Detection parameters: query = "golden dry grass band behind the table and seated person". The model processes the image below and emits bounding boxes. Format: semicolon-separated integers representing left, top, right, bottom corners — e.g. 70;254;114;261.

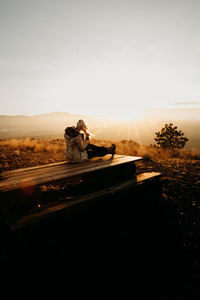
0;138;200;170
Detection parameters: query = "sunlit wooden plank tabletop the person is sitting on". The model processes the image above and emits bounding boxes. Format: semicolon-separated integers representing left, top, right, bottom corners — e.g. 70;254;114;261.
0;155;142;192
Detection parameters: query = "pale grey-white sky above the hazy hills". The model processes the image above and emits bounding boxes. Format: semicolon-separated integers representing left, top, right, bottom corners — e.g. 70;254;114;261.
0;0;200;119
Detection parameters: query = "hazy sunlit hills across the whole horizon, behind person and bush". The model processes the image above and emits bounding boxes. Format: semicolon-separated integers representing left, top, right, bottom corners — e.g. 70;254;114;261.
0;111;200;150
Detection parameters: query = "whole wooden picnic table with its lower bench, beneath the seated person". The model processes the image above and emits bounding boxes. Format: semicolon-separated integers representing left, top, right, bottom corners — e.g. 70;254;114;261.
0;155;161;229
